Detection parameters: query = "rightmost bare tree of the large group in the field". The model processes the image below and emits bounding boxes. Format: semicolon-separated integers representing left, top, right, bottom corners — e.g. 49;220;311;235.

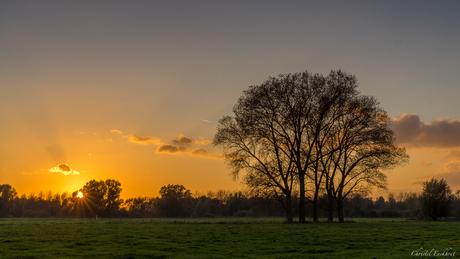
322;95;408;222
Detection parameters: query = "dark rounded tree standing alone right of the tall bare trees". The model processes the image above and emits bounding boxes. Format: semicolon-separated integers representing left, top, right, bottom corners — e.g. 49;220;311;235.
420;178;453;221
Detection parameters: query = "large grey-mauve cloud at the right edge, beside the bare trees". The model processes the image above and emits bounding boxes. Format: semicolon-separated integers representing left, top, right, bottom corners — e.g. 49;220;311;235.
390;114;460;148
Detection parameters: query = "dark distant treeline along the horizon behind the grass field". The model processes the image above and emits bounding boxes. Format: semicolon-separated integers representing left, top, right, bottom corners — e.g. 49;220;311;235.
0;179;460;220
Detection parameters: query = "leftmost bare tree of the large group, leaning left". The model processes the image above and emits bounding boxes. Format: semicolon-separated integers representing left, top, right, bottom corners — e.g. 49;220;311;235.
213;116;294;222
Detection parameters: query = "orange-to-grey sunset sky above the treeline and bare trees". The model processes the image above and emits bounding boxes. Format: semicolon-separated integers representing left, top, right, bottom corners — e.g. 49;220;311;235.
0;0;460;198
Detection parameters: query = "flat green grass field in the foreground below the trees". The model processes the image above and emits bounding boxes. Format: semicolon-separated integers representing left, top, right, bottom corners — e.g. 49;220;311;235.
0;219;460;259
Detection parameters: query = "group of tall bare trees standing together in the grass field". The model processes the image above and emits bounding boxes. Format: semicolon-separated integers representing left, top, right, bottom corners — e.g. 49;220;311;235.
213;70;408;222
